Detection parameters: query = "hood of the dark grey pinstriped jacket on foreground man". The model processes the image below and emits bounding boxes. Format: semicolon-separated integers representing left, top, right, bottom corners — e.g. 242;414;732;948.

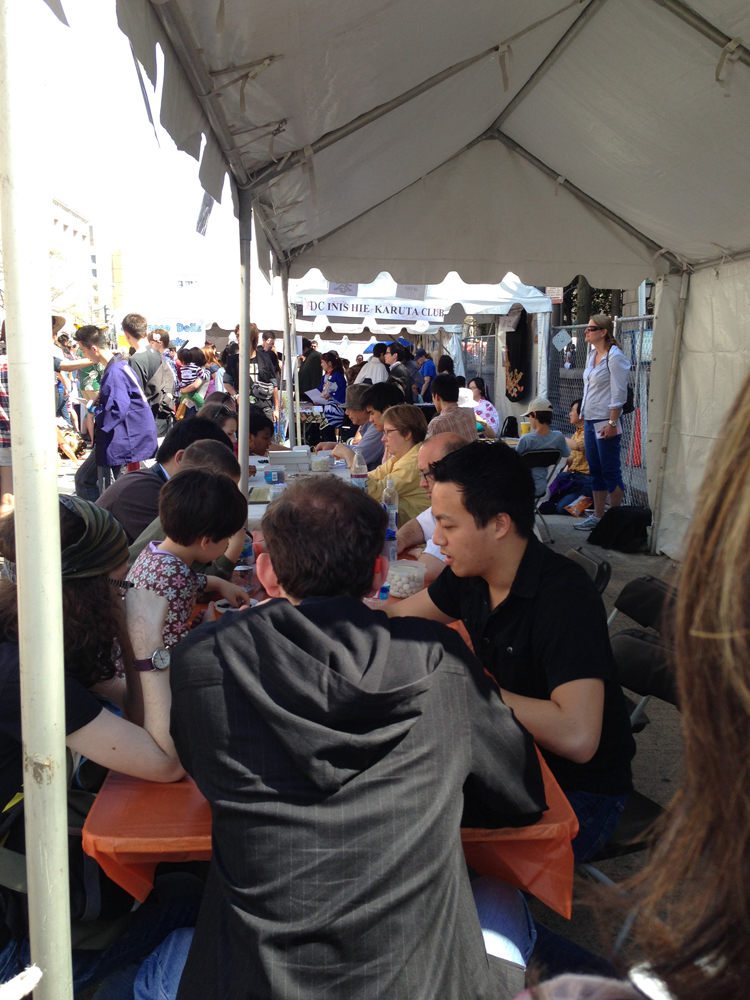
216;597;444;793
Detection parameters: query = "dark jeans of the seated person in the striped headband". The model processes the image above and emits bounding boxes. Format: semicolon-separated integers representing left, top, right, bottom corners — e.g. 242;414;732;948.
0;872;203;1000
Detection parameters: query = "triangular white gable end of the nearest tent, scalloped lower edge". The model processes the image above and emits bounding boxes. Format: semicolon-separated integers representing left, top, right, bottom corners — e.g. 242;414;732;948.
292;142;664;288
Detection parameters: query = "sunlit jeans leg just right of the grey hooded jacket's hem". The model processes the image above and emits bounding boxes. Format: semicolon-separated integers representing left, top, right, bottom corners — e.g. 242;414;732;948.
471;875;536;968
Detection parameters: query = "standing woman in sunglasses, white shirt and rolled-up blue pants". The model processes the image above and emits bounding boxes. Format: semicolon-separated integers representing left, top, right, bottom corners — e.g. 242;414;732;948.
576;315;630;531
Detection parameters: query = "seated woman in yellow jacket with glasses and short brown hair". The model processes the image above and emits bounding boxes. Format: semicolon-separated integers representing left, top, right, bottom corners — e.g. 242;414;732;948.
367;403;430;528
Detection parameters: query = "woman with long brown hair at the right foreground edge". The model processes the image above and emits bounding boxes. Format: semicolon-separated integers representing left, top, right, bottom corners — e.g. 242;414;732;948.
533;370;750;1000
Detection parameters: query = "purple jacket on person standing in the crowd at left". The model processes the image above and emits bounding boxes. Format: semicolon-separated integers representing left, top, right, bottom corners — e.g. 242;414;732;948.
95;355;157;465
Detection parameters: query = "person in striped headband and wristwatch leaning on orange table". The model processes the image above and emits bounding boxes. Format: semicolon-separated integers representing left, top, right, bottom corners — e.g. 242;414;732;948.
0;496;202;995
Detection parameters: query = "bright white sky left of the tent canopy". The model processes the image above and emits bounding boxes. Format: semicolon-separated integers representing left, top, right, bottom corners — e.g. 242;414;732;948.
27;0;280;326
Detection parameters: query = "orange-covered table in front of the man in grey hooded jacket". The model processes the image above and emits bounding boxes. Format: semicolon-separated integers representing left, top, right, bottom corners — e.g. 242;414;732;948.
83;752;578;917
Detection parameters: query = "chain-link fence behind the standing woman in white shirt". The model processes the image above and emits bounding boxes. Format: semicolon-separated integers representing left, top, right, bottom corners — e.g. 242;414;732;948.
547;316;654;506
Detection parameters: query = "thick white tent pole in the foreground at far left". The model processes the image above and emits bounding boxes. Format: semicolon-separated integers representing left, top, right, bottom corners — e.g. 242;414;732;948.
0;0;73;1000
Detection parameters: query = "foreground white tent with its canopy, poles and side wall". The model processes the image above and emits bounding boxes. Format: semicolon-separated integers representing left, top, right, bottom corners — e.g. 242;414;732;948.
0;0;750;1000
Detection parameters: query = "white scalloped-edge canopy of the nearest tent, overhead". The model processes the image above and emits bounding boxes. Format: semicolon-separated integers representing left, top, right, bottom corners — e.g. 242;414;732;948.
110;0;750;554
